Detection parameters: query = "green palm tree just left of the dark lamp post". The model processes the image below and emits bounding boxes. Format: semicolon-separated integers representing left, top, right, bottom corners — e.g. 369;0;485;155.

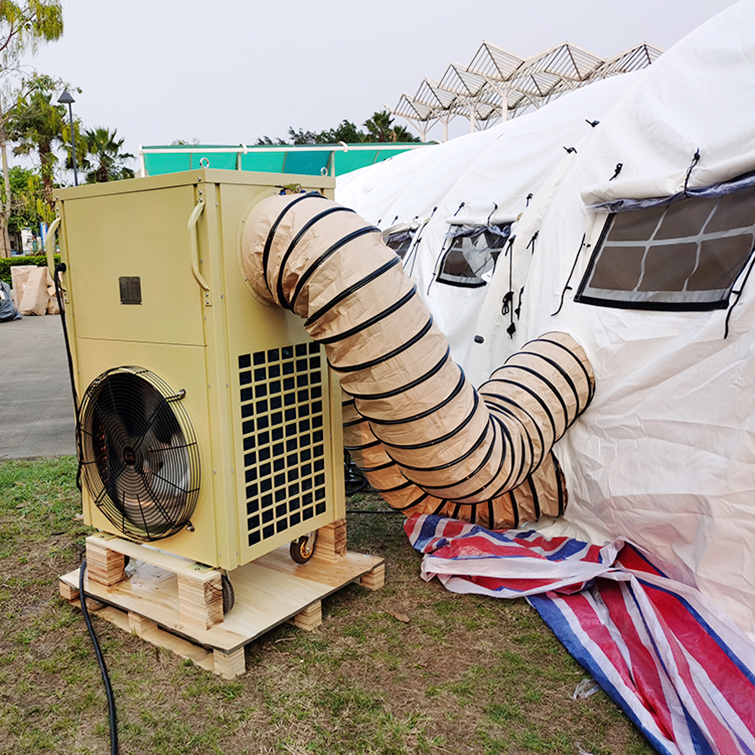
7;74;66;208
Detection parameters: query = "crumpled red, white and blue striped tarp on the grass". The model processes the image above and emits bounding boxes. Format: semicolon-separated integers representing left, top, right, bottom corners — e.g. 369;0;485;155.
404;515;755;755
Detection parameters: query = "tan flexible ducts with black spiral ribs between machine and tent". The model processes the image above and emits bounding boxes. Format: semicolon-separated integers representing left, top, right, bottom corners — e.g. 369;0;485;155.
242;194;594;527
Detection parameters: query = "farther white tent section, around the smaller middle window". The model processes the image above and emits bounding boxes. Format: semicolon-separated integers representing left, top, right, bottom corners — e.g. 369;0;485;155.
336;73;637;370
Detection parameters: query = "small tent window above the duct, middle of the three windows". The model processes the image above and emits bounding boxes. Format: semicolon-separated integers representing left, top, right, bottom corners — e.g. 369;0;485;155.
438;223;511;288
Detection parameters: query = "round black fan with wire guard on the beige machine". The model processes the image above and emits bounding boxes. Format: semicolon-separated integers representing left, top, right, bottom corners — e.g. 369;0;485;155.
80;367;200;541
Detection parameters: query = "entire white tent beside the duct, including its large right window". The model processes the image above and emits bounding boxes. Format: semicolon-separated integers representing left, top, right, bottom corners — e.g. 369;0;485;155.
339;1;755;632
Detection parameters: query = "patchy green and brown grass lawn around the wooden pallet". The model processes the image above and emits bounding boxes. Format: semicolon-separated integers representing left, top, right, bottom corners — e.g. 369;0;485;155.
0;458;653;755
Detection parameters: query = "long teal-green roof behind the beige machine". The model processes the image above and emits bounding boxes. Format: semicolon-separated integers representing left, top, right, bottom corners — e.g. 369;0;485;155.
139;142;425;176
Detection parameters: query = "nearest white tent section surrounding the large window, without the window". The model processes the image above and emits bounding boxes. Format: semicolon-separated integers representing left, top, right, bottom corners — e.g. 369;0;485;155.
466;2;755;632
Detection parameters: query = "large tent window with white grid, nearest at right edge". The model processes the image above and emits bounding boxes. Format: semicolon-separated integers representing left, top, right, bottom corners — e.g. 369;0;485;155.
575;186;755;311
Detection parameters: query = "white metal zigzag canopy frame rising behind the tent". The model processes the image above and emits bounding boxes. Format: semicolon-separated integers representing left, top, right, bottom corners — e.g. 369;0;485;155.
389;42;662;141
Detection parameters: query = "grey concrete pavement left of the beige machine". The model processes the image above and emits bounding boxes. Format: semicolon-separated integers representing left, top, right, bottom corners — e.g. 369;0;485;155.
0;315;76;459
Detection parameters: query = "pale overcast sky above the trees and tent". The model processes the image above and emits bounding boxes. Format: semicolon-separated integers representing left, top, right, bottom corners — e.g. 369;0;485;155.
17;0;734;167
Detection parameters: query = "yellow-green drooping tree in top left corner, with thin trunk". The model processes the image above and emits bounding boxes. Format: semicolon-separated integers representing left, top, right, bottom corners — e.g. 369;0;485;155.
0;0;63;257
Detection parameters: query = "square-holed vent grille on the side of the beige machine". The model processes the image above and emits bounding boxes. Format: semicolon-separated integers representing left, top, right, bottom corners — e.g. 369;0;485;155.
238;343;326;546
